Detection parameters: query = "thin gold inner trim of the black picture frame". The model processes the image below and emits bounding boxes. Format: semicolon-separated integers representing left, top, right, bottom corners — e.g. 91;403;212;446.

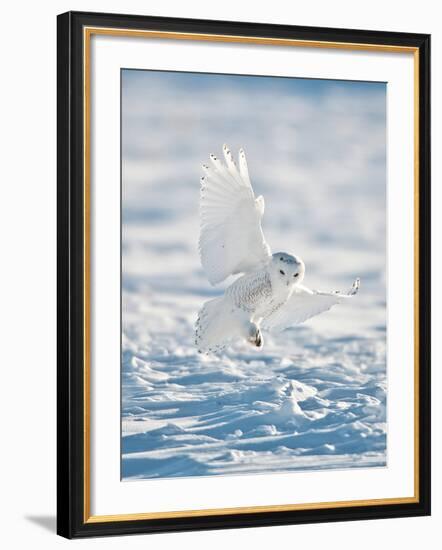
83;27;419;523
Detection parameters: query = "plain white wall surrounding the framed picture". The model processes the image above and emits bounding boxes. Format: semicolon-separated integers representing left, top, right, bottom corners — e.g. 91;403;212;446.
0;0;442;550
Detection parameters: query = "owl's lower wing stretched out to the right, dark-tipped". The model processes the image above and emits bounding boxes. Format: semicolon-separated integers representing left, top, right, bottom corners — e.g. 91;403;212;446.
262;279;360;332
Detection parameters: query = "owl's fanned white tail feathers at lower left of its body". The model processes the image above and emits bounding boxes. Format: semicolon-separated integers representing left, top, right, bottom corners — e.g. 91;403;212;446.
195;296;238;353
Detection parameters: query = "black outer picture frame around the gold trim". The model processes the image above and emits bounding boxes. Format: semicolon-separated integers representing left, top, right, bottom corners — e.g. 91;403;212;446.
57;12;431;538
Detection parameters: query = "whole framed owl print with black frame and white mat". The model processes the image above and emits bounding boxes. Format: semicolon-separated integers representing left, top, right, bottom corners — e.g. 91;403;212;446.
58;12;430;538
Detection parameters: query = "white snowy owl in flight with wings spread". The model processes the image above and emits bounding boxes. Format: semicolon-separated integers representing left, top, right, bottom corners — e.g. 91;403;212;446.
195;145;359;353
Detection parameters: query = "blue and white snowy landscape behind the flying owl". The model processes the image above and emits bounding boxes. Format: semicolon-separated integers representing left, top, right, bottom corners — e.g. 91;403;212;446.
122;71;387;479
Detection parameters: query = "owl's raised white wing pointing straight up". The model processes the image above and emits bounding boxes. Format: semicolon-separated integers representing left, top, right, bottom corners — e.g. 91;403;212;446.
199;145;271;284
